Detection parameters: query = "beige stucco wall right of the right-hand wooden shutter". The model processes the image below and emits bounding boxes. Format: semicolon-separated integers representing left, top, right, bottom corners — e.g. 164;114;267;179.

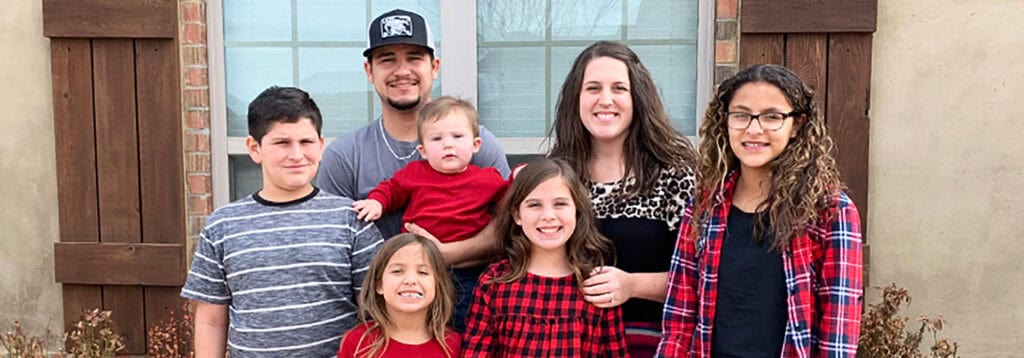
868;0;1024;357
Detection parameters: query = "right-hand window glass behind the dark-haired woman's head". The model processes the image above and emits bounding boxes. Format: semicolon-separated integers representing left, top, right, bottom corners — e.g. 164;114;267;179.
477;0;698;137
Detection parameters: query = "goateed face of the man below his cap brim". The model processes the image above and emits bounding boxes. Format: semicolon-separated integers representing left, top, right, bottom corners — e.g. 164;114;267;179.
364;45;440;110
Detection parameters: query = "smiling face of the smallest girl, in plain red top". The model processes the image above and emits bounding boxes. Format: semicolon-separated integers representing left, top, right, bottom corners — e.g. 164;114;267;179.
377;243;436;317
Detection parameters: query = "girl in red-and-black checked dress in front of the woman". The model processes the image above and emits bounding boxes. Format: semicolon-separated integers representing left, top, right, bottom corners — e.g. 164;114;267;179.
463;159;627;357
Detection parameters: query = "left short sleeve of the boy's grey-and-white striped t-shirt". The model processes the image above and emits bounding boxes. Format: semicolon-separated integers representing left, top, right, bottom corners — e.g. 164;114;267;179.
181;227;231;305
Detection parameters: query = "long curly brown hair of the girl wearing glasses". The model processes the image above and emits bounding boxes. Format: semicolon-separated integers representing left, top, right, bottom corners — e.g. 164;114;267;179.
691;64;844;250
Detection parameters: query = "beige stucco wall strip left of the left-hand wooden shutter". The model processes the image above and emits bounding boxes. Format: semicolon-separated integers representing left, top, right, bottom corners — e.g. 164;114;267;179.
0;0;63;347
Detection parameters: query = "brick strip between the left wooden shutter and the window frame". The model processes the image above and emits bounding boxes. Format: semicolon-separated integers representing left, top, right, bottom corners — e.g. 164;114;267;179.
178;0;213;251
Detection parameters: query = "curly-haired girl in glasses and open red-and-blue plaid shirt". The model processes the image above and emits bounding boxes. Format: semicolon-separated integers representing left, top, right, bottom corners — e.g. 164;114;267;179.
658;64;863;357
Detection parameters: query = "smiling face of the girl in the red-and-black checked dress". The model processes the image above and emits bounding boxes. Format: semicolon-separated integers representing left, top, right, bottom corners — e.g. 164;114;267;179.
513;176;577;253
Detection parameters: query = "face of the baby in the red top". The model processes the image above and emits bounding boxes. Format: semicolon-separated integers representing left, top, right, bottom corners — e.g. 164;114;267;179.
417;108;481;174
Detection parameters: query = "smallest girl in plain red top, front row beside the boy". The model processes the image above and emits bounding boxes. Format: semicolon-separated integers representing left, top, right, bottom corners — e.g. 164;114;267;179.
338;233;462;358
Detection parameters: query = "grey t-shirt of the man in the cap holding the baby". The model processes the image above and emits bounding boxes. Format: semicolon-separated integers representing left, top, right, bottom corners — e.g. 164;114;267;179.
316;118;509;238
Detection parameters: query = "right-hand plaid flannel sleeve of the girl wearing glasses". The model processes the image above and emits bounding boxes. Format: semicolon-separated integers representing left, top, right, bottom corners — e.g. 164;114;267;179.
816;192;864;357
